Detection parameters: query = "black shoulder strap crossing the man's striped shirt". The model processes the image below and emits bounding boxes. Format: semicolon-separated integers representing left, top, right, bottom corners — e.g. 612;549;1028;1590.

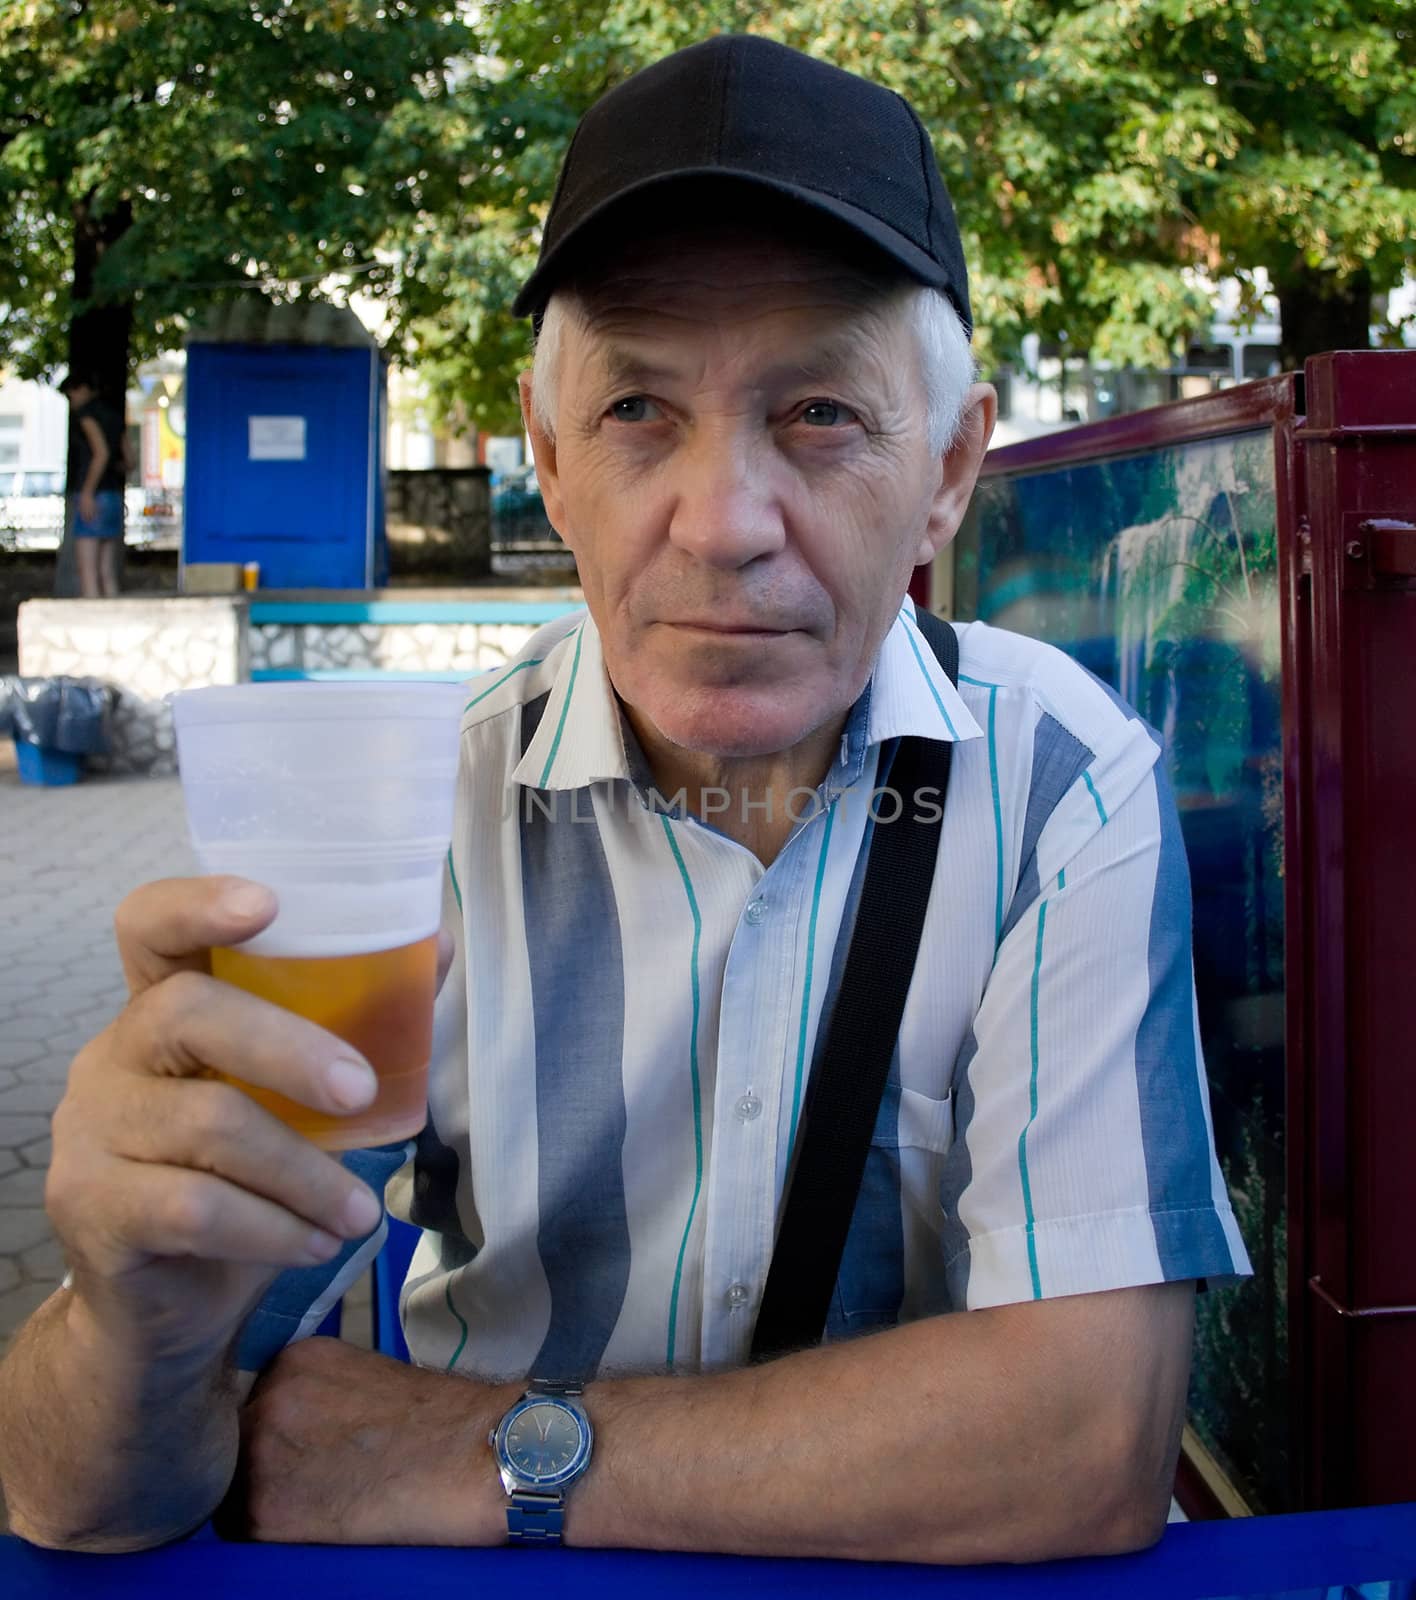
752;610;958;1360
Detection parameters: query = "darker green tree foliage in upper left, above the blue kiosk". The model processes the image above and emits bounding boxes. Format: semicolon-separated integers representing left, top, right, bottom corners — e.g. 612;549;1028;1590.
0;0;470;389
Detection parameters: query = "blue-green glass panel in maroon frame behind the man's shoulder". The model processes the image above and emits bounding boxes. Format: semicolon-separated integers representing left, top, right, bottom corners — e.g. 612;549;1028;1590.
955;430;1288;1510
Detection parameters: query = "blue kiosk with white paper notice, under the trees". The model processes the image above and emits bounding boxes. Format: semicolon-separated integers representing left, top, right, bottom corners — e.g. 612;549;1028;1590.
182;296;387;589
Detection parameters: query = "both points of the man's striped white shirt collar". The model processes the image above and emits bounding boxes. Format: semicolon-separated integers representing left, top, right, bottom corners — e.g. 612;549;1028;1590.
512;600;982;790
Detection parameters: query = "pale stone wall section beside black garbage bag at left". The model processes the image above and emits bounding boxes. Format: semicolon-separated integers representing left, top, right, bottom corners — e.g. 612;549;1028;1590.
19;597;250;773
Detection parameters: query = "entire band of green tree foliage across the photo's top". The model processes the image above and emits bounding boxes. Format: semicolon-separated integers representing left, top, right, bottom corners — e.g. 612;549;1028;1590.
0;0;1416;429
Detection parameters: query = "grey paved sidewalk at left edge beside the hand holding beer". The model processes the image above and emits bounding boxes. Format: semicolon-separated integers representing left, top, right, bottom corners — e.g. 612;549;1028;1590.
0;761;194;1355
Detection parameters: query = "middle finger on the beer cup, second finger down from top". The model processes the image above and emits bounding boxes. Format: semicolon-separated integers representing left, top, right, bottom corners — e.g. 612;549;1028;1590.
105;971;378;1115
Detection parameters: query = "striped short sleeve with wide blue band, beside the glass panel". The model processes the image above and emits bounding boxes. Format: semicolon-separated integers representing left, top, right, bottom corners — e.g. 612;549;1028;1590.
941;755;1251;1309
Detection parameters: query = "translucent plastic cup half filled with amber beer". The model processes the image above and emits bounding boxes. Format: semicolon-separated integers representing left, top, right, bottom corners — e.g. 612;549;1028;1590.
173;682;464;1150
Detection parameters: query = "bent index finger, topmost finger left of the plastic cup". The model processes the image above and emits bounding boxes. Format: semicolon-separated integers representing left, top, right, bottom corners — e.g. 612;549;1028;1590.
114;874;275;995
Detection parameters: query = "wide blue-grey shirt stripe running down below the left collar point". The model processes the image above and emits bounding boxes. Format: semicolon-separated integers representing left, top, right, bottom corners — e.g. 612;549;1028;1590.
520;777;629;1378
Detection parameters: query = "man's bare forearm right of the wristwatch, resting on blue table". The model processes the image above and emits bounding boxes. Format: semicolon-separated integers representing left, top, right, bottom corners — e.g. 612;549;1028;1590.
566;1286;1182;1563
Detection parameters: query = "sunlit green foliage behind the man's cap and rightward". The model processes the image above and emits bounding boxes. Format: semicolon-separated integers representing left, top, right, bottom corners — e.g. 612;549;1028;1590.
419;0;1416;419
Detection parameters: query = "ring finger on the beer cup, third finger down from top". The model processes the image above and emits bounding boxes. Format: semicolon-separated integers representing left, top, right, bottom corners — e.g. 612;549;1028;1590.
107;1078;384;1238
